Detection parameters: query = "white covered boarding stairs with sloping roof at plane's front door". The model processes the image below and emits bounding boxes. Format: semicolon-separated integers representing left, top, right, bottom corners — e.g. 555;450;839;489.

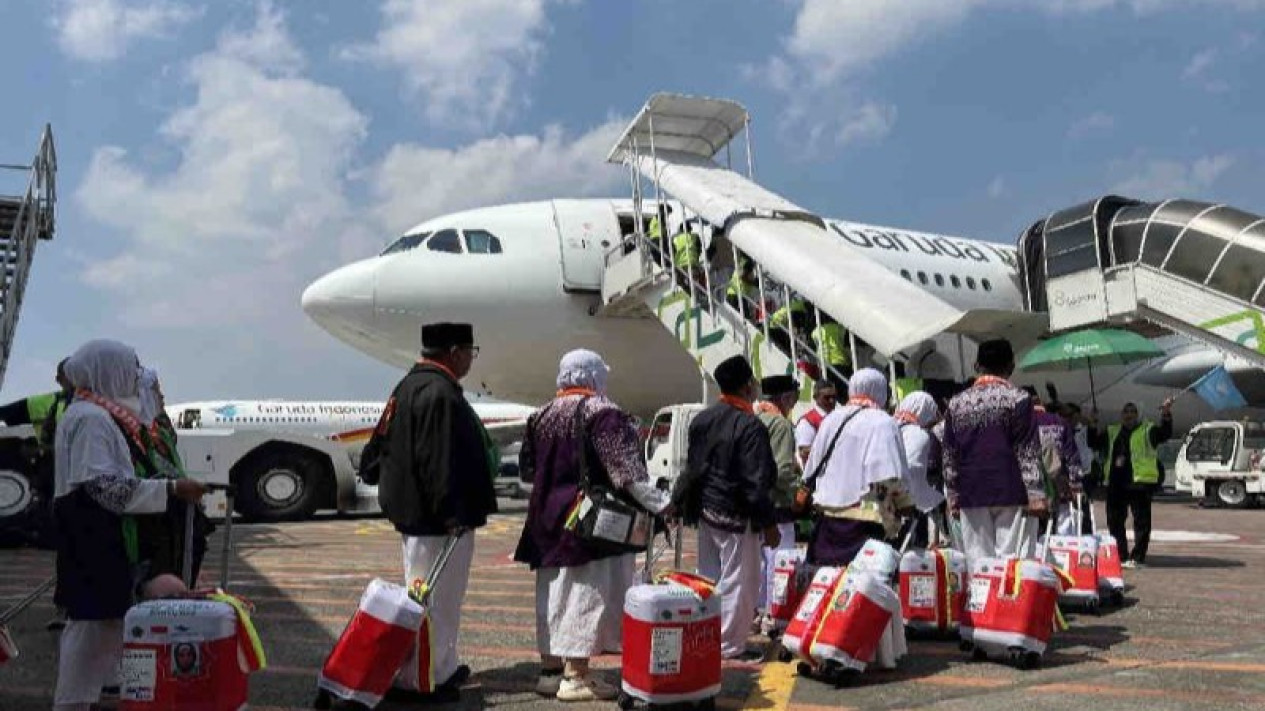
601;94;1045;394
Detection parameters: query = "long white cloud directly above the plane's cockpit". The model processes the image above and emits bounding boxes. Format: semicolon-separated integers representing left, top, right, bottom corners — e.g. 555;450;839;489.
372;119;627;234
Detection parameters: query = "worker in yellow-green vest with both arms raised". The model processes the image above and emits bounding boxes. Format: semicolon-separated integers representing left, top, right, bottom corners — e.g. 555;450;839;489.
1089;397;1173;568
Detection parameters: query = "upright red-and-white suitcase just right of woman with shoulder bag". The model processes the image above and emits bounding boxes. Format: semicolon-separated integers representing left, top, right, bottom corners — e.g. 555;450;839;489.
619;573;721;710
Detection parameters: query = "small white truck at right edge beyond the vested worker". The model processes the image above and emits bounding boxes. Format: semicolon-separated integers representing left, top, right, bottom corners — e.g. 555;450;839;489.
1175;420;1265;507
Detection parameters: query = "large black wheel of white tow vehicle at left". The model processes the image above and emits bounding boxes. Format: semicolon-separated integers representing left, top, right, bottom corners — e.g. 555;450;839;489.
235;452;323;521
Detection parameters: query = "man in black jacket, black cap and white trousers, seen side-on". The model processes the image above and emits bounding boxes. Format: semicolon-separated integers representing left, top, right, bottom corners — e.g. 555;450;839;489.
374;324;496;701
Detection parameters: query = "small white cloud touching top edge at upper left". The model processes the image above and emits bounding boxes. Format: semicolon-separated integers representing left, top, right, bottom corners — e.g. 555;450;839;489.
52;0;201;62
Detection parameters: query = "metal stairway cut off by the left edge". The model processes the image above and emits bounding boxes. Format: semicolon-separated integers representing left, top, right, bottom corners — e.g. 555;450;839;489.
0;125;57;385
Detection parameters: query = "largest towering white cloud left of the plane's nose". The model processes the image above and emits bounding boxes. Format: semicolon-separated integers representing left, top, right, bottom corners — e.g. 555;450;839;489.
77;5;367;328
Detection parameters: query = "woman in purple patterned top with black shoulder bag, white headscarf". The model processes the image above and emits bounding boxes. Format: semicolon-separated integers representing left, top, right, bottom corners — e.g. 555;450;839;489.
515;350;669;701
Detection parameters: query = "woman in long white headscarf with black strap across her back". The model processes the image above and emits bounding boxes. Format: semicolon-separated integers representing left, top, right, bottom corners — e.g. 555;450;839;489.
805;368;912;566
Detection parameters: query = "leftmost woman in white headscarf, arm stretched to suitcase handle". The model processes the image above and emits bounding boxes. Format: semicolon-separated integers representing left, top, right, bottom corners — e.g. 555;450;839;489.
53;340;204;711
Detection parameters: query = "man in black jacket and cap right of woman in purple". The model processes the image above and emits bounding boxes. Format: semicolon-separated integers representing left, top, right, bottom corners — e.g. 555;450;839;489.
673;356;781;659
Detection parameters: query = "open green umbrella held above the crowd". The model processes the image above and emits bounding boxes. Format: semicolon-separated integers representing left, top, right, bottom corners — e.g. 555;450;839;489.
1020;329;1164;407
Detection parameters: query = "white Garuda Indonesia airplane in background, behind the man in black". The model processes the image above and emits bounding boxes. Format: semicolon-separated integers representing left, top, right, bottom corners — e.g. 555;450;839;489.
167;400;534;445
